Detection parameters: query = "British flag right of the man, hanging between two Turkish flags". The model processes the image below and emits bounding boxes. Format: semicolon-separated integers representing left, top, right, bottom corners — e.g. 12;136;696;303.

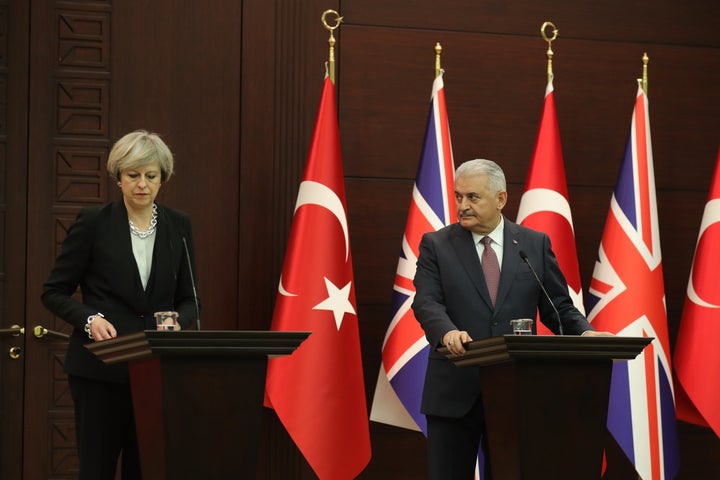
586;82;679;480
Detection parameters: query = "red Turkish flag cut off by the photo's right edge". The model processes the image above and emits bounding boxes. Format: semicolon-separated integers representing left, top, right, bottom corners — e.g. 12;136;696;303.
673;147;720;437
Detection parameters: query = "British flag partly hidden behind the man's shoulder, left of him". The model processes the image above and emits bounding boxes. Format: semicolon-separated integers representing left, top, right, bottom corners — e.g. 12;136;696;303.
370;74;457;434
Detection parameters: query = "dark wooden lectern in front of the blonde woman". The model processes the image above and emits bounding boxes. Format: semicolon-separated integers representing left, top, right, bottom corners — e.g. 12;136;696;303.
87;330;310;480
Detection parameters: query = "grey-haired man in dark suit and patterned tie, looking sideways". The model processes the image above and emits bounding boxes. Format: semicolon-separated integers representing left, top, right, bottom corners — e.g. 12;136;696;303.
412;160;603;480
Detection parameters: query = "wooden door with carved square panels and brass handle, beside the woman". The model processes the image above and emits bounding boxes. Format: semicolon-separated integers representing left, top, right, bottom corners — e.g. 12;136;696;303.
22;0;111;479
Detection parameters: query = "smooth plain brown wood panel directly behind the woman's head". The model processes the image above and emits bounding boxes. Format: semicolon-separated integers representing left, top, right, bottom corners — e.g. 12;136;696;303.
111;0;242;329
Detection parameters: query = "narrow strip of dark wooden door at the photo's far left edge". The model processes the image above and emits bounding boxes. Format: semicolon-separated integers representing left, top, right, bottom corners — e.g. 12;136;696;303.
0;0;29;480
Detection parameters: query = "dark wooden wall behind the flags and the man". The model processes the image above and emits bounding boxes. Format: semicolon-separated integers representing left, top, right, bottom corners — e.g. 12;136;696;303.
338;0;720;478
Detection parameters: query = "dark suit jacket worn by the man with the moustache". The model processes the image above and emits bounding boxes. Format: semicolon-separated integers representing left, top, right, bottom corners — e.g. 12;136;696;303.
412;218;593;418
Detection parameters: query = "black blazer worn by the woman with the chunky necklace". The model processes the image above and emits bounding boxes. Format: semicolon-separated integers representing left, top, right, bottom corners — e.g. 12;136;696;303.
42;200;197;382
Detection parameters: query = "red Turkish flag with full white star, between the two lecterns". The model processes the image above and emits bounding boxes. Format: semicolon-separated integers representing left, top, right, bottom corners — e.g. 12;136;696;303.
266;77;370;480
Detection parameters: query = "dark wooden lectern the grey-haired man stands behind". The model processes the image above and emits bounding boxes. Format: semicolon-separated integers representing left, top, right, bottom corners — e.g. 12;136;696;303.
440;335;653;480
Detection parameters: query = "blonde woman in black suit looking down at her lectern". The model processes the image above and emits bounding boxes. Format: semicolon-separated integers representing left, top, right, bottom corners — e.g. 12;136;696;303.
42;130;199;480
